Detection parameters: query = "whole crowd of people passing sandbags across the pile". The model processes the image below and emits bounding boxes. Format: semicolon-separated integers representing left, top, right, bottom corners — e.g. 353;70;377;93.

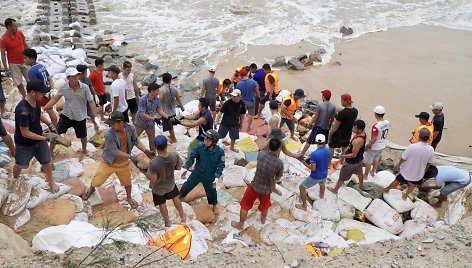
0;18;470;229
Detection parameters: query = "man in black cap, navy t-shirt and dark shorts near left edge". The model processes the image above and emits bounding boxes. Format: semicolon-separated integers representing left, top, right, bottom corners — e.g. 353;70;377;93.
13;80;59;193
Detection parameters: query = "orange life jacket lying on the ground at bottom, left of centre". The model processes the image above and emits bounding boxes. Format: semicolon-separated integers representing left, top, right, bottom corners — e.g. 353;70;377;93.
147;225;192;260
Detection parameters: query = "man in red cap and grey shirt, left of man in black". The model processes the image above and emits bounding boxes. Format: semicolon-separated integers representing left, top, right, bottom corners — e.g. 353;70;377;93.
300;89;336;155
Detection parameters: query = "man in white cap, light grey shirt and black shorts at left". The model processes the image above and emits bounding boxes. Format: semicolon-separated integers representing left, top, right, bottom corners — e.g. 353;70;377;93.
44;68;96;155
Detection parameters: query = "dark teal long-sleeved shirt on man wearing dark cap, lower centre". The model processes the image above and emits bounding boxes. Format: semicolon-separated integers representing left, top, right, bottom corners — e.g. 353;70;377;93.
184;144;225;181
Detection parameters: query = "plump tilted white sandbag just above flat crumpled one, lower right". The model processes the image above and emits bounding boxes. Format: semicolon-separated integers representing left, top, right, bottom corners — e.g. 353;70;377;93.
365;199;404;234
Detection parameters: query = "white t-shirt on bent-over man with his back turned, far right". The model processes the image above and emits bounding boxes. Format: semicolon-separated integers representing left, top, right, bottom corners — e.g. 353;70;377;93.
400;142;434;181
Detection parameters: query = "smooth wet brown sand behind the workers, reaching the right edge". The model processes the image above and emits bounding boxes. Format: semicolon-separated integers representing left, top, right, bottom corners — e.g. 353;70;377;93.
218;25;472;157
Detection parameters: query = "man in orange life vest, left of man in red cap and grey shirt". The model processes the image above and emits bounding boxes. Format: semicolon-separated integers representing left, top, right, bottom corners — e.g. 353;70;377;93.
280;88;305;141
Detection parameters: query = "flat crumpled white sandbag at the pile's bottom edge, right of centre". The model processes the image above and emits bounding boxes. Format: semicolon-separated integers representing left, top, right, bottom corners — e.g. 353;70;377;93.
336;219;400;244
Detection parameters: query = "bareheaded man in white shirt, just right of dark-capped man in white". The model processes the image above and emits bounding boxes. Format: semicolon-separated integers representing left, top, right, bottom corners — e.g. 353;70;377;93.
118;61;139;124
